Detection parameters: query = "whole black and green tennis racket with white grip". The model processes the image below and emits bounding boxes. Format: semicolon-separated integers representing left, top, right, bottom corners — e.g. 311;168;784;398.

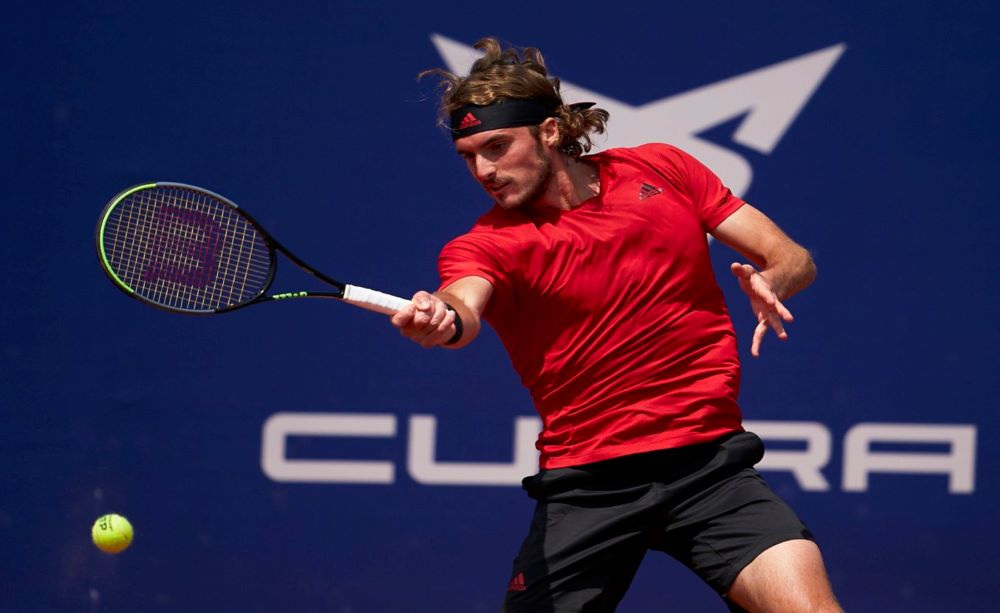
97;182;410;315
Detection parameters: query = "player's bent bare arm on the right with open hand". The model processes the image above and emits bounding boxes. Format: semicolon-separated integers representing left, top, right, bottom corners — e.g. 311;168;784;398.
712;204;816;357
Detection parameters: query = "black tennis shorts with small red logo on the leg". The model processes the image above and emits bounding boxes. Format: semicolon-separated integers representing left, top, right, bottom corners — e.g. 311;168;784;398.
504;432;813;613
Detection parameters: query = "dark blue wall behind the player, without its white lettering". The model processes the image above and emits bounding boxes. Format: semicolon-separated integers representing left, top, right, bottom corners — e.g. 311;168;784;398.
0;0;1000;613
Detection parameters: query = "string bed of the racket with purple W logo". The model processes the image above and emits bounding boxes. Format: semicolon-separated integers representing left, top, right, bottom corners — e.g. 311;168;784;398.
102;186;273;311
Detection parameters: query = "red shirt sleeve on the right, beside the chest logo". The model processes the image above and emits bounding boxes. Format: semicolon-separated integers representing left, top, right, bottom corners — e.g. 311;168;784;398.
644;144;746;232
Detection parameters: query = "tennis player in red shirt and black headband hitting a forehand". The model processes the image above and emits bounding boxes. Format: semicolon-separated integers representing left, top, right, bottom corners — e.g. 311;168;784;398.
392;38;840;613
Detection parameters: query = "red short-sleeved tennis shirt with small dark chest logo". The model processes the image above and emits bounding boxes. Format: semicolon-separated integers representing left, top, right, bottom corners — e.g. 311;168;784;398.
438;144;744;469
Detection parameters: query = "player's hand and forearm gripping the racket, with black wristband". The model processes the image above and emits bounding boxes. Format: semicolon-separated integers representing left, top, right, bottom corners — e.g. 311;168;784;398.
392;276;493;349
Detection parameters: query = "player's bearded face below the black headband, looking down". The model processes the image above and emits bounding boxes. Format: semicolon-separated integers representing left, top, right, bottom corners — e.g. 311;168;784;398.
455;127;552;209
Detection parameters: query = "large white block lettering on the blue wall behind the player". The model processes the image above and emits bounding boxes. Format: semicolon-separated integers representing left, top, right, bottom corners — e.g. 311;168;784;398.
261;413;976;494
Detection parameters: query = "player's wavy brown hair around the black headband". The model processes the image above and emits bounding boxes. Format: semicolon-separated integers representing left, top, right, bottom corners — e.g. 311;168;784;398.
417;37;609;157
